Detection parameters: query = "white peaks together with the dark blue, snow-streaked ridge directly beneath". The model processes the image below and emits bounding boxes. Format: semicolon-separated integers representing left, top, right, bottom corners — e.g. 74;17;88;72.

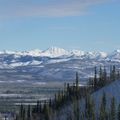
0;47;120;68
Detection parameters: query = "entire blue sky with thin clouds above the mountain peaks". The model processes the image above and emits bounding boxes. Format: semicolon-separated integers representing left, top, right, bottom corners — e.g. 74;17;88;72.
0;0;120;52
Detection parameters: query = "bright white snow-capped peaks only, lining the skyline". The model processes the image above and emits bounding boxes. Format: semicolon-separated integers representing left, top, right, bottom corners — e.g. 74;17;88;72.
0;47;120;59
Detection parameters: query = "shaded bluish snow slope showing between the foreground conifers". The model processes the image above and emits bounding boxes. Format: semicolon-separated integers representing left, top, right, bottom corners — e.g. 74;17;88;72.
52;80;120;120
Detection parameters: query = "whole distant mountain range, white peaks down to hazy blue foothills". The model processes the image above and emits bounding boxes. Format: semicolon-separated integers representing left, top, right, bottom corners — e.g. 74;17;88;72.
0;47;120;80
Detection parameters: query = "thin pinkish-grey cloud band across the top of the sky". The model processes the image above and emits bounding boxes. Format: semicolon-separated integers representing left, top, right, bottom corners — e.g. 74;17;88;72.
0;0;112;18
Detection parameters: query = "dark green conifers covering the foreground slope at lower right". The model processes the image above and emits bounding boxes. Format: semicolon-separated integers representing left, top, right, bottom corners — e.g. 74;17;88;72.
16;66;120;120
